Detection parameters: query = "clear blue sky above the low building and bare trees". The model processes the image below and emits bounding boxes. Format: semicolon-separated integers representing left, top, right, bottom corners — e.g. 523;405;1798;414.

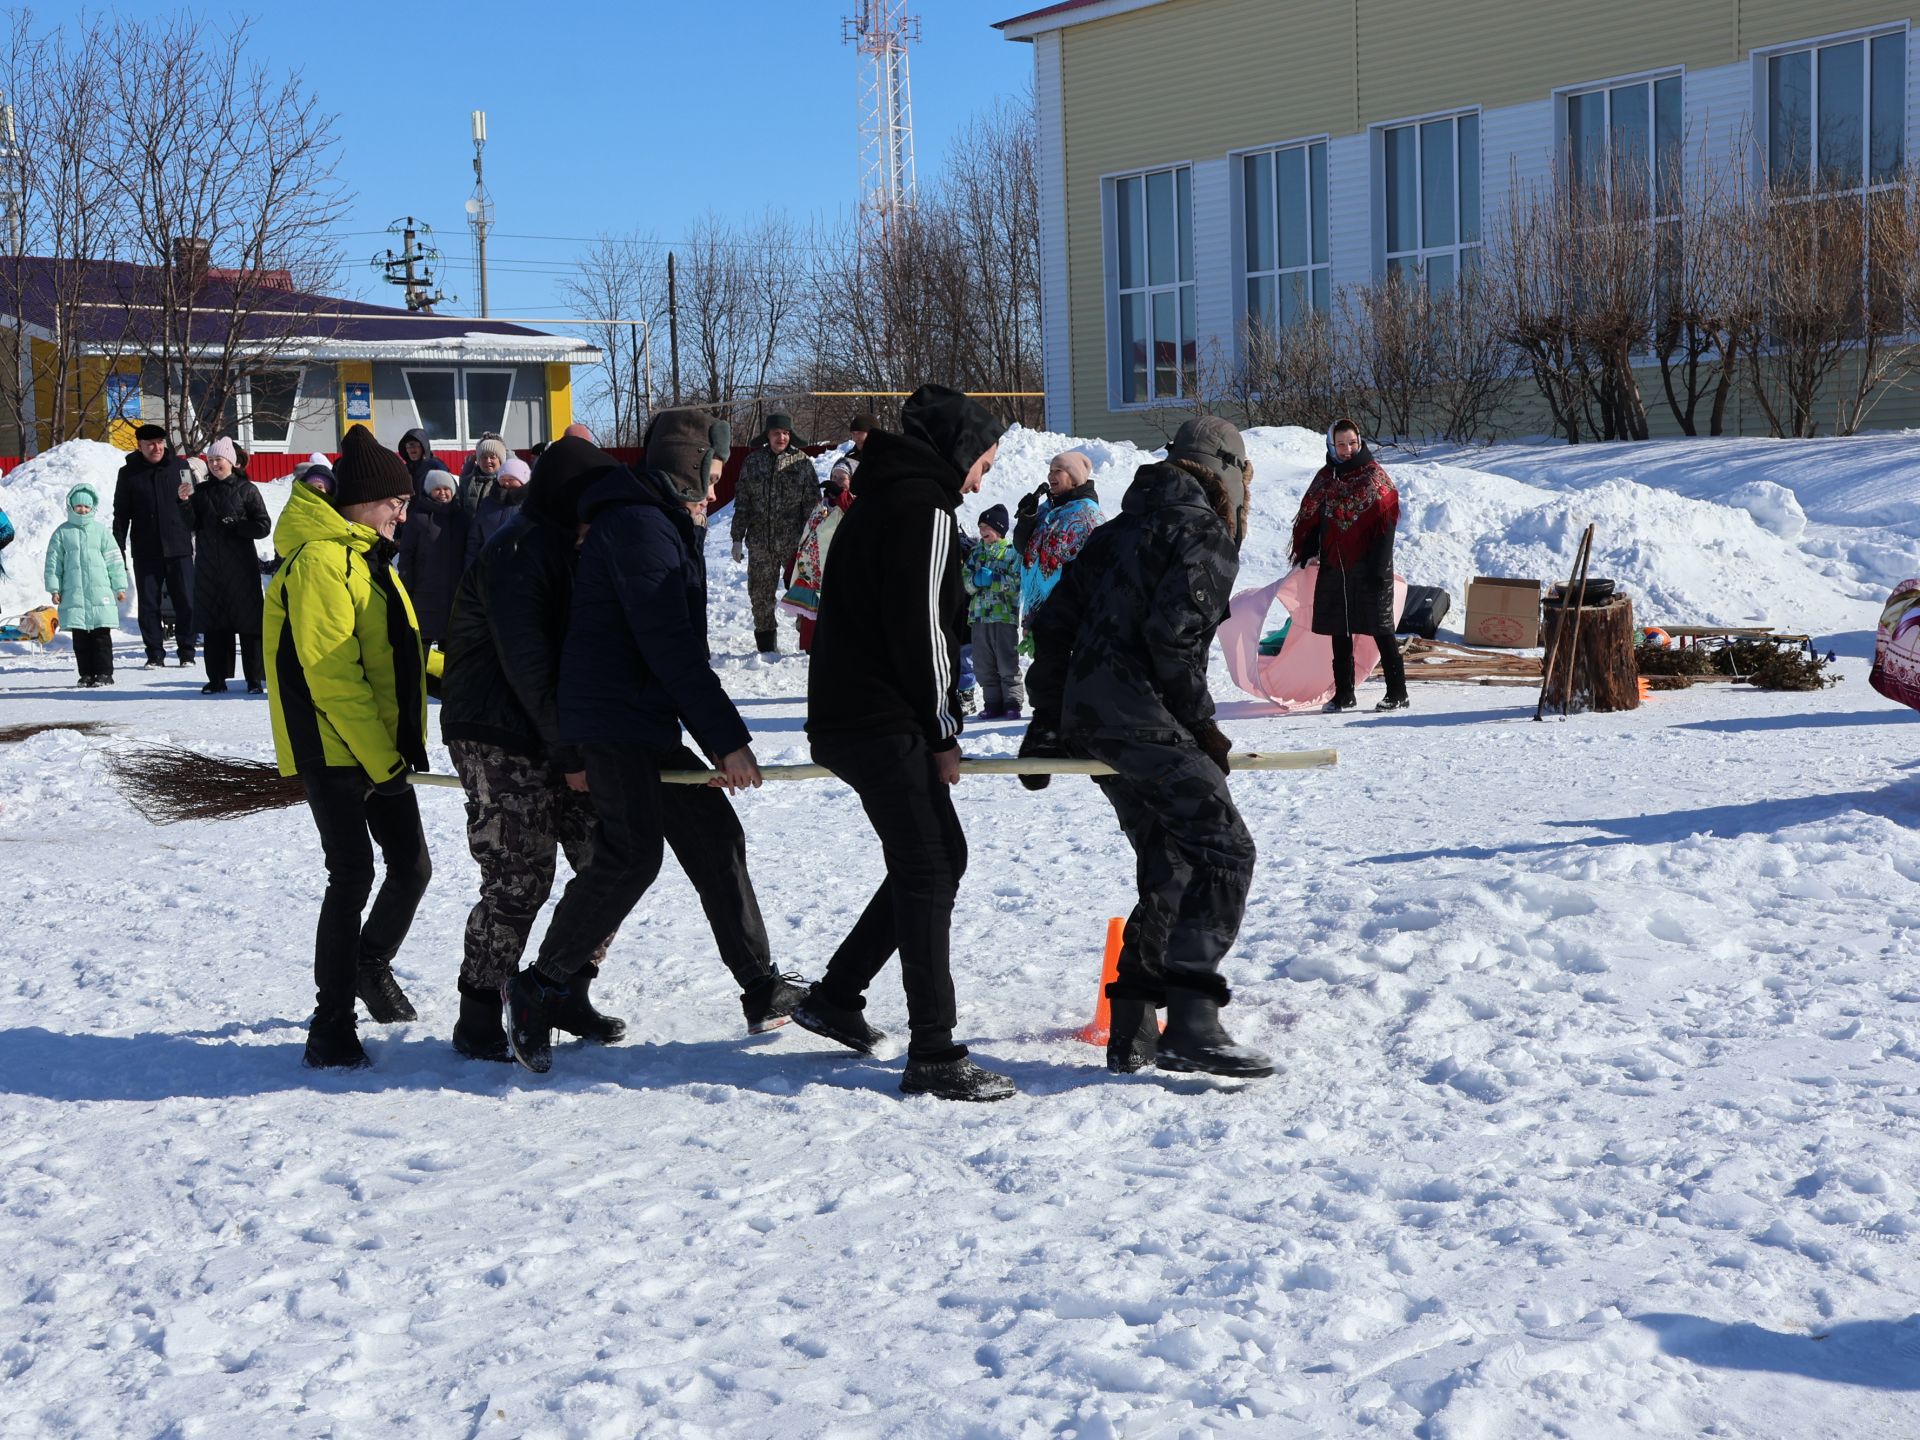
176;0;1033;315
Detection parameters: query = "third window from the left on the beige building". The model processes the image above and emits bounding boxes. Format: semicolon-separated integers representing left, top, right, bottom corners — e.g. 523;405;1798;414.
1380;111;1480;294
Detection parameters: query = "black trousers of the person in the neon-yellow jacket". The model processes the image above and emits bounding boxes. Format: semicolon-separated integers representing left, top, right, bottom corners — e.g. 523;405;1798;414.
300;764;434;1012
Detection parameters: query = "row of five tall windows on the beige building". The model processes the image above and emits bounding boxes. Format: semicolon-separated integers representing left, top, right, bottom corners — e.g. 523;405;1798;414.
1110;29;1907;405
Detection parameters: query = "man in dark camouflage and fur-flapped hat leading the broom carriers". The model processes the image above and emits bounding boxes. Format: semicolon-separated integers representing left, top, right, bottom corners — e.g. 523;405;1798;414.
1021;417;1273;1077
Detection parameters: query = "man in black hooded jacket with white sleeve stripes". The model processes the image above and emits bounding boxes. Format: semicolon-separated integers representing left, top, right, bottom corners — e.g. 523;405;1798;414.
793;386;1014;1100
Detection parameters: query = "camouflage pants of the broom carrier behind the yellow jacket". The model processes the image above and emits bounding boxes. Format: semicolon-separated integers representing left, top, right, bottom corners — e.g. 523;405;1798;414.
447;739;612;989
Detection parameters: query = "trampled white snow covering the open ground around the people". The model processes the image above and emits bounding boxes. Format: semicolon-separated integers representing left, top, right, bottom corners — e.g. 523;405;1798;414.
0;430;1920;1440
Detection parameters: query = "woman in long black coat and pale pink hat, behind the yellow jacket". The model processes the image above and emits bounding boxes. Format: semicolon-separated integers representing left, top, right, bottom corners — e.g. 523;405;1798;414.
192;436;273;695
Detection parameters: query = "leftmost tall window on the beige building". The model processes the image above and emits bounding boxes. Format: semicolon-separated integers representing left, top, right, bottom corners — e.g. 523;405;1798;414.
1112;165;1200;405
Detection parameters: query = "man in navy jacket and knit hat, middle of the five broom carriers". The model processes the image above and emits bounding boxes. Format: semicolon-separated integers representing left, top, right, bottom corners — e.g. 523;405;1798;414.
505;411;760;1071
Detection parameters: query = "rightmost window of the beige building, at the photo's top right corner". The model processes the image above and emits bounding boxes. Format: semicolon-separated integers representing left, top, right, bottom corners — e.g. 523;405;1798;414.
1766;31;1907;196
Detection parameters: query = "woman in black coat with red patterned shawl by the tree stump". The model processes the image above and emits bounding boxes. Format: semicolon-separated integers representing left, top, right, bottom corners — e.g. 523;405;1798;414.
1294;420;1407;710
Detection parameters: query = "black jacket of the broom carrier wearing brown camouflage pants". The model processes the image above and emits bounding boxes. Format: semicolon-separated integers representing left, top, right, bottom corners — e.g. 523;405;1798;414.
440;511;582;770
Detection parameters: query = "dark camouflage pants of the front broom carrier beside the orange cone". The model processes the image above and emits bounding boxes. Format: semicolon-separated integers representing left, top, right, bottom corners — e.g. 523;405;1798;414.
1077;739;1254;1002
